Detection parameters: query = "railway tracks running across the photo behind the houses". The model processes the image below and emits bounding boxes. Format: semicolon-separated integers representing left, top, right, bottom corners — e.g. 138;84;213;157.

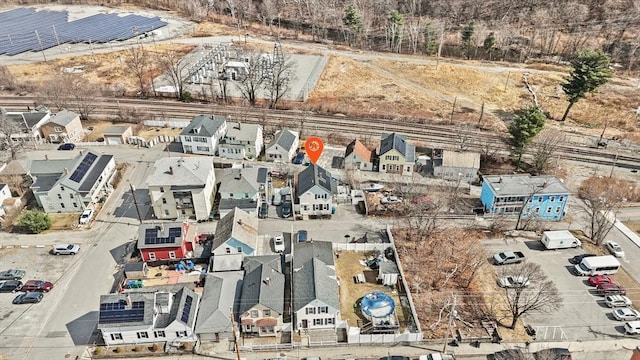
0;96;640;170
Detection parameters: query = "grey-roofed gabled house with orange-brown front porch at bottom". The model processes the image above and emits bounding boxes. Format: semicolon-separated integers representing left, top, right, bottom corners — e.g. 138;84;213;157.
238;255;285;336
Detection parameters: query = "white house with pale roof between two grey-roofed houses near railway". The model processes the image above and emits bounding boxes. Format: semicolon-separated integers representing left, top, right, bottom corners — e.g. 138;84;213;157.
218;122;264;160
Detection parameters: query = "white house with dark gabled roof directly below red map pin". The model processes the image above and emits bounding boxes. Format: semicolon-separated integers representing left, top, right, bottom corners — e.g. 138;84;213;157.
296;164;336;216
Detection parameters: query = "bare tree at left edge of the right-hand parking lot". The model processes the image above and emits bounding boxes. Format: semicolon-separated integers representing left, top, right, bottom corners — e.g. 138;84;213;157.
498;262;562;329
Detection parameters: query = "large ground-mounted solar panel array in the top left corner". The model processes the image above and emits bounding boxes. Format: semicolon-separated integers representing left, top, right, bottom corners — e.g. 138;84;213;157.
0;8;167;56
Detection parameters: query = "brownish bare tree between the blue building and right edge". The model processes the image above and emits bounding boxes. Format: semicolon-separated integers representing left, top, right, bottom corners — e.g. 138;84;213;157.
578;176;630;245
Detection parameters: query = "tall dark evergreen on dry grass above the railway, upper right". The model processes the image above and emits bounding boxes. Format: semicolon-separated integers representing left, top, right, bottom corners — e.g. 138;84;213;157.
561;50;612;121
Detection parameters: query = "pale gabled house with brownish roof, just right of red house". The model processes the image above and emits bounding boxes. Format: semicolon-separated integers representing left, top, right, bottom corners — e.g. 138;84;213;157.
211;208;258;256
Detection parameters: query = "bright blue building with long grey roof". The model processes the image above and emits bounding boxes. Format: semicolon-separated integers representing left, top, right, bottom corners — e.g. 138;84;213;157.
480;174;569;221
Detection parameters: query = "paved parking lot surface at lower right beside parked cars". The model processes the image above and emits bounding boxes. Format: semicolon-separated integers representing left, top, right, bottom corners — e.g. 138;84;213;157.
485;238;624;341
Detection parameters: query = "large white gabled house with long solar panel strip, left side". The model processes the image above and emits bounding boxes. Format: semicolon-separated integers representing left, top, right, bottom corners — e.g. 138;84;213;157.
30;150;116;213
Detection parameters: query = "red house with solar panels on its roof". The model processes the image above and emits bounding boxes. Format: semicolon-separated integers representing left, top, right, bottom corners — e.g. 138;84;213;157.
138;222;196;261
